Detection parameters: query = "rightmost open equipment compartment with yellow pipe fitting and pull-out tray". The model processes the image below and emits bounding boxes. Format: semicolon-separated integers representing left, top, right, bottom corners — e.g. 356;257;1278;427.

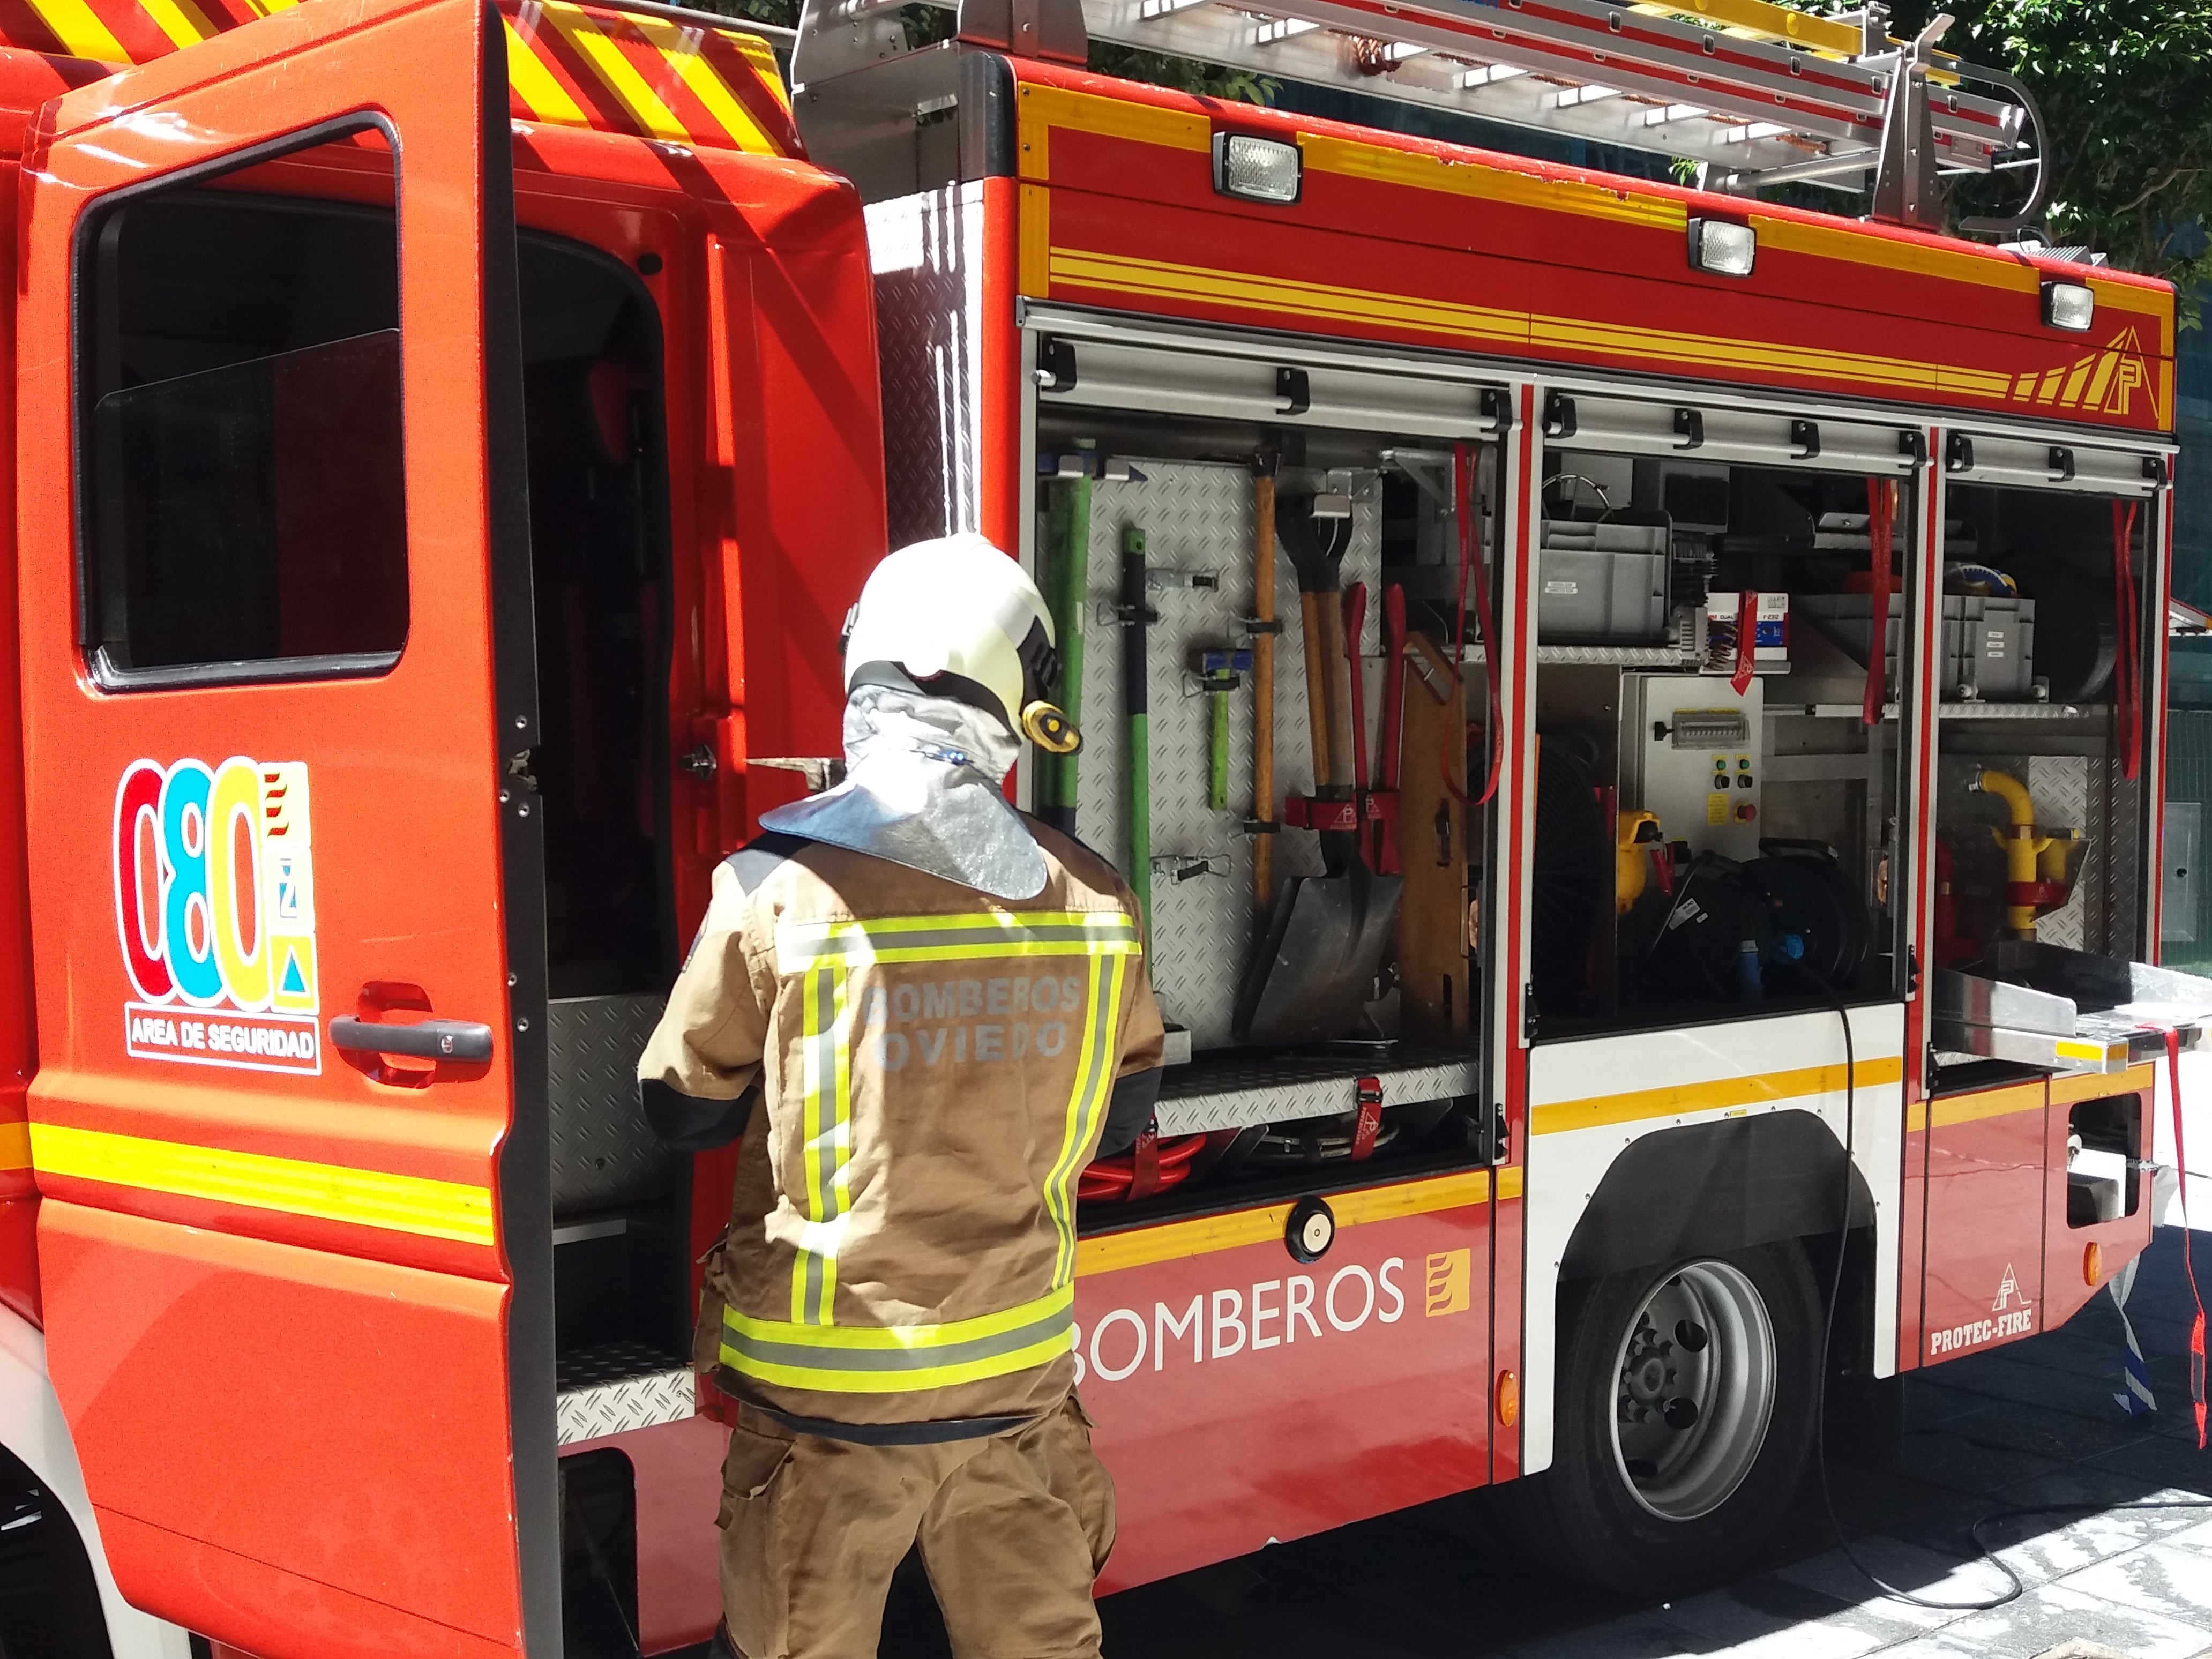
1929;431;2212;1093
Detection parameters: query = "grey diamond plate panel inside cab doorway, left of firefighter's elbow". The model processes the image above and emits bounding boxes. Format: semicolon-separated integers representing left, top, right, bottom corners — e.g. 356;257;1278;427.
547;996;675;1219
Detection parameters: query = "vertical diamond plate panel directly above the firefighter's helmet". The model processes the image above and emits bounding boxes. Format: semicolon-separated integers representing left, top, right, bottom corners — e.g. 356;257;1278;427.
867;184;982;547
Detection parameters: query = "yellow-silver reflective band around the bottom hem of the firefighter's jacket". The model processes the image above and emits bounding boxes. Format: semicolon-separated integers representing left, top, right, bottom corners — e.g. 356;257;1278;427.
721;1285;1075;1394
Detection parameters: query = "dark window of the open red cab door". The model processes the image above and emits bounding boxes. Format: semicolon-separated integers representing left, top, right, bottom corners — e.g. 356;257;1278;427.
77;151;407;690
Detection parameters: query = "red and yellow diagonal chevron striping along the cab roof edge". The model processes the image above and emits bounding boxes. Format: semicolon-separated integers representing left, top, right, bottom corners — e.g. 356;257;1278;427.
0;0;803;155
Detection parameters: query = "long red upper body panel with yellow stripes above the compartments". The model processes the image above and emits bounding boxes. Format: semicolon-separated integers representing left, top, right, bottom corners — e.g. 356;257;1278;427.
1018;64;2174;434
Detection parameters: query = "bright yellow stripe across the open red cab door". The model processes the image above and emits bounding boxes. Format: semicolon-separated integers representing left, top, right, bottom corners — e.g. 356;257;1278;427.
31;1124;496;1247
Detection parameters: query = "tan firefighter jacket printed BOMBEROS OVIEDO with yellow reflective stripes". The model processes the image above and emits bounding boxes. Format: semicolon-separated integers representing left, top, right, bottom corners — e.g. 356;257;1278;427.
639;823;1161;1424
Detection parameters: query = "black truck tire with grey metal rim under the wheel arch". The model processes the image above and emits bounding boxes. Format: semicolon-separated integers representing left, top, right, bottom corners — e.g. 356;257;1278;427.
1500;1241;1820;1597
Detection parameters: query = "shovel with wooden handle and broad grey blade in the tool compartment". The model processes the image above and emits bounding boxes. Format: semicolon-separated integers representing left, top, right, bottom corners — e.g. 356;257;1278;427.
1234;496;1402;1047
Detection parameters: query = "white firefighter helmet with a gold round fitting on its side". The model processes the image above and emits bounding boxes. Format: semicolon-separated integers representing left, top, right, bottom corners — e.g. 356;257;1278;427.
845;533;1082;754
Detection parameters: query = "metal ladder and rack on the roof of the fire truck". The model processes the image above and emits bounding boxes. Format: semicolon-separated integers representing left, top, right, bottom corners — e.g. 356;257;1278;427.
792;0;2044;235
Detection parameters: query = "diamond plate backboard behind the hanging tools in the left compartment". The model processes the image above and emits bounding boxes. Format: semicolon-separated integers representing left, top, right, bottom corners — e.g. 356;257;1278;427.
1057;453;1382;1052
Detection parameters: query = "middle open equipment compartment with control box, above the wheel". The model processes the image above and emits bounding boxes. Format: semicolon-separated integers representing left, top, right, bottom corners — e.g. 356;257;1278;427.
1531;392;1924;1037
